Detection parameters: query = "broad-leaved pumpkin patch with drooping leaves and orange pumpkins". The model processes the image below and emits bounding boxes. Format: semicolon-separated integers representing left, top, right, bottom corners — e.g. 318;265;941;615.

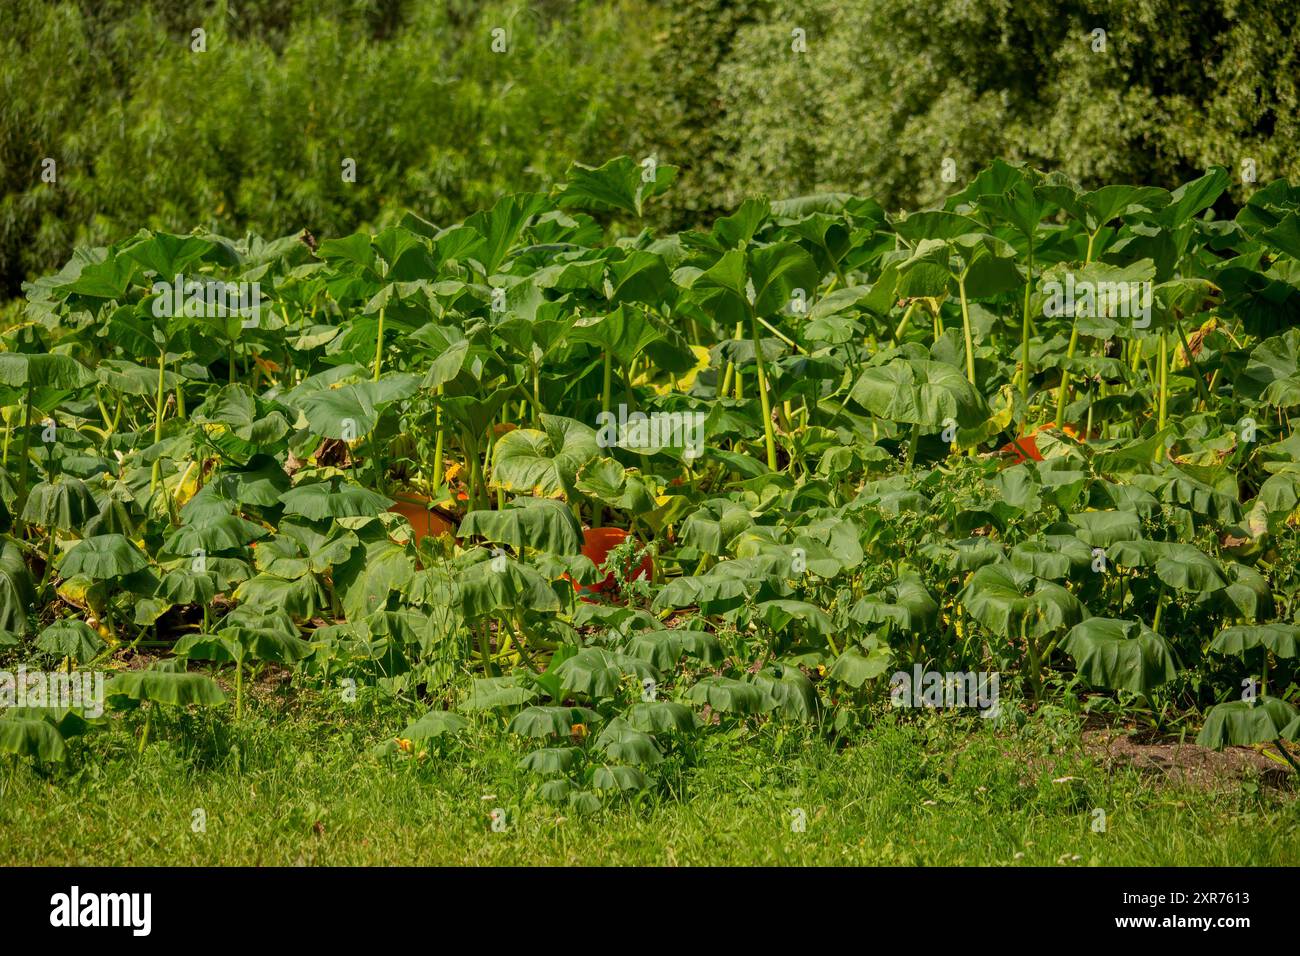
0;157;1300;808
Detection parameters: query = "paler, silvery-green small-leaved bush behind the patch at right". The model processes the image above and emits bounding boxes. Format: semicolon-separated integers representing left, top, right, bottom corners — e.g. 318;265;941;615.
645;0;1300;222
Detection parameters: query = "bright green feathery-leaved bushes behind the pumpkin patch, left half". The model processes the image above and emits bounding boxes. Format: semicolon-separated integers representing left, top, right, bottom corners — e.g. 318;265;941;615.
0;0;647;295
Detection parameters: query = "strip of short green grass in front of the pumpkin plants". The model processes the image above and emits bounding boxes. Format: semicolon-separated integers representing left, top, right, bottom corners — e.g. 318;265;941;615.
0;697;1300;865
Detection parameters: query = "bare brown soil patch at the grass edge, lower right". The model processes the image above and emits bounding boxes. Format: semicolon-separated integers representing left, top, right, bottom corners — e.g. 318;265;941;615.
1083;730;1296;790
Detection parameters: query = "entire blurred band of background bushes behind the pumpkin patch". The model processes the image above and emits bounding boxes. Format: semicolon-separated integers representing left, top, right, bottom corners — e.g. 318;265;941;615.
0;0;1300;298
